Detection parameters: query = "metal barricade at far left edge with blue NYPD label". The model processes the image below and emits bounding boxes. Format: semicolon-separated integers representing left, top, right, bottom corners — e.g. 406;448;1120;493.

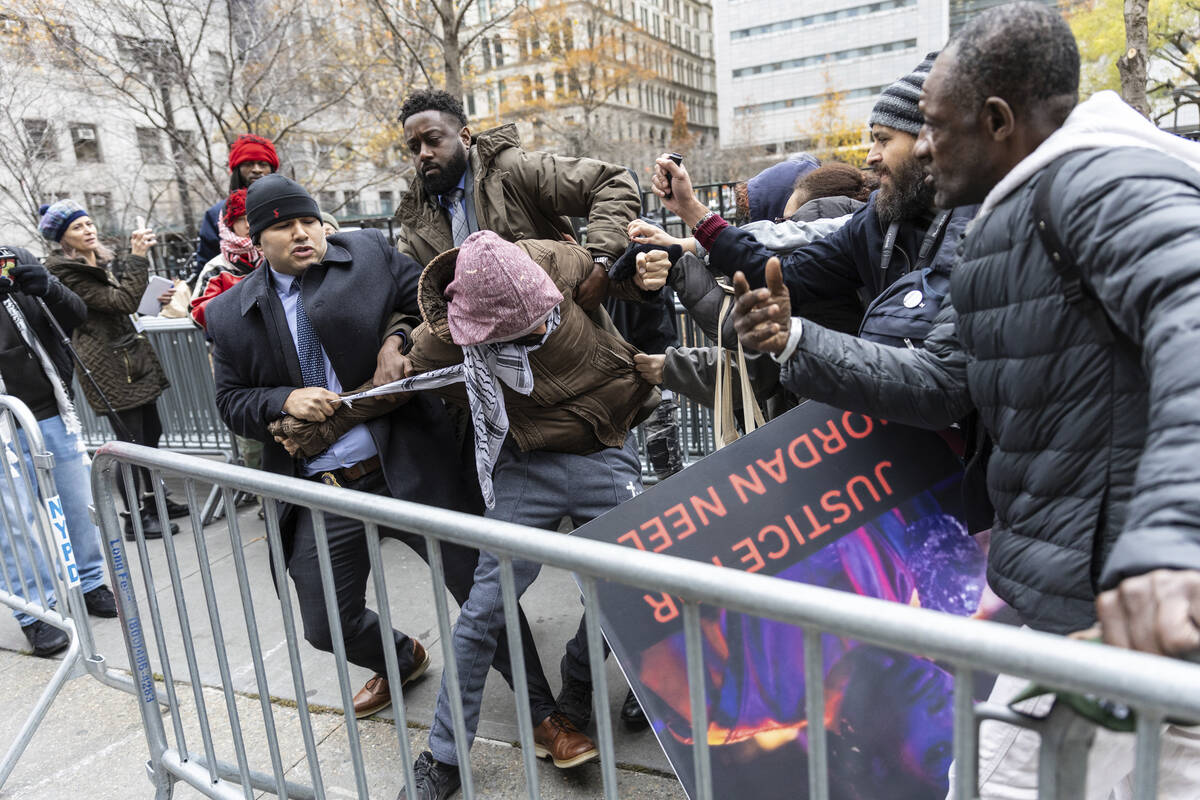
0;393;132;787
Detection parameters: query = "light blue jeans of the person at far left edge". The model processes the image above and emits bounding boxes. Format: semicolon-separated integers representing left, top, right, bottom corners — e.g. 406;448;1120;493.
0;416;104;626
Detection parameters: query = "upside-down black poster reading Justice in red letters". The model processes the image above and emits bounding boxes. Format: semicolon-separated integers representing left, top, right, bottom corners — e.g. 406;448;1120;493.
574;402;1010;800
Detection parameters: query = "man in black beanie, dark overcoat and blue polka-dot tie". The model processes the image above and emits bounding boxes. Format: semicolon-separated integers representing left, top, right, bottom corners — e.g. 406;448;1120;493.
205;175;553;729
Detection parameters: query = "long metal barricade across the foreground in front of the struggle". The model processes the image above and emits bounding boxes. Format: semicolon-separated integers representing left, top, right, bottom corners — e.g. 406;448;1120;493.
92;443;1200;800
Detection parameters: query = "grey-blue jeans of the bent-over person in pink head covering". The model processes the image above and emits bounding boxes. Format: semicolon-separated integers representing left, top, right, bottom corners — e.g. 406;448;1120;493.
430;435;642;764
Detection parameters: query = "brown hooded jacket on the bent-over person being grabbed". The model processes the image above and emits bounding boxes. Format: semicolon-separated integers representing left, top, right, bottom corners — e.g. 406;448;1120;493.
270;241;659;457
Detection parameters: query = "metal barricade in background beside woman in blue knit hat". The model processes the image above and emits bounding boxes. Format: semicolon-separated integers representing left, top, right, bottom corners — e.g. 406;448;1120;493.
74;317;240;524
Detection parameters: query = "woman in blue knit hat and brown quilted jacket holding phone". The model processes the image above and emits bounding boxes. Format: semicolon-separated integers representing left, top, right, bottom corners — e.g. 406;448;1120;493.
38;200;187;540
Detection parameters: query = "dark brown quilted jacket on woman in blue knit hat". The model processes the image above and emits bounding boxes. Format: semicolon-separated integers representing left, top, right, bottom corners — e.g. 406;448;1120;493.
46;255;170;414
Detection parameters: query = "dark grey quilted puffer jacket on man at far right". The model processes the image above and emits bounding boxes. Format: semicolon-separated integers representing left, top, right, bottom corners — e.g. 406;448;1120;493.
784;148;1200;632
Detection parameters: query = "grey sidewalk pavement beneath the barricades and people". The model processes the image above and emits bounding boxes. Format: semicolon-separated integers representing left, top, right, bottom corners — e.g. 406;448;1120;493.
0;487;684;800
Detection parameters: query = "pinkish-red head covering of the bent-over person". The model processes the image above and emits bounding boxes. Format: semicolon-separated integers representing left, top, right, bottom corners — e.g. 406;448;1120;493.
445;230;563;347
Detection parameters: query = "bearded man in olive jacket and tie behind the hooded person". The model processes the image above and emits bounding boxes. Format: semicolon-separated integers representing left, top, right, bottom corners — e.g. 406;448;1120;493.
396;90;642;312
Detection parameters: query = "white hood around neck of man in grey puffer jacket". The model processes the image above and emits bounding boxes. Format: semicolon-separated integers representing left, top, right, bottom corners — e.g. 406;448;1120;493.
976;91;1200;222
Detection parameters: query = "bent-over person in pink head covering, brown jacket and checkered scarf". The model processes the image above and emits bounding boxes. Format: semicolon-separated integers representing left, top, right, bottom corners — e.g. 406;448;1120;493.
272;230;667;799
